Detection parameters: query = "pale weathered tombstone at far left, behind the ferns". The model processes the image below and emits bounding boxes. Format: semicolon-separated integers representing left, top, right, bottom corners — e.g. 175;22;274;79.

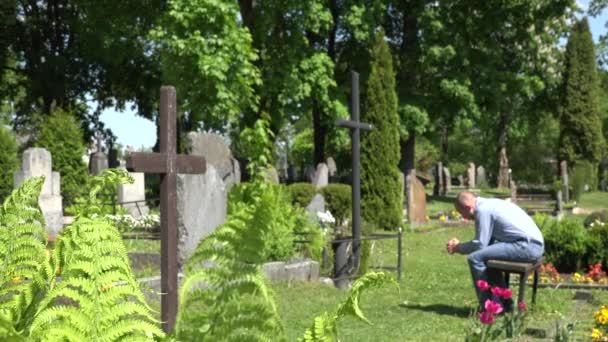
13;147;63;237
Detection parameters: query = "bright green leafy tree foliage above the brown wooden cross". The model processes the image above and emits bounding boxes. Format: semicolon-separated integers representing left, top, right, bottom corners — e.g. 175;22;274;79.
152;0;261;131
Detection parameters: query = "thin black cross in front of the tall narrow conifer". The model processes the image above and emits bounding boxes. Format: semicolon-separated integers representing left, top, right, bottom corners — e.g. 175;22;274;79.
336;71;374;268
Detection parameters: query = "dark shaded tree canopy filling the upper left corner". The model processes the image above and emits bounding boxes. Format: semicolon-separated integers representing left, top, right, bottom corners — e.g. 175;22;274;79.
0;0;166;134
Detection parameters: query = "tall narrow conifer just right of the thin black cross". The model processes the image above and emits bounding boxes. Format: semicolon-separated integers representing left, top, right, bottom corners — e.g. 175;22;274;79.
361;30;402;230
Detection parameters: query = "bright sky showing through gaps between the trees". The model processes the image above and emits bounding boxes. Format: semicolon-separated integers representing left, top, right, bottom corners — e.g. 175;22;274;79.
101;0;608;149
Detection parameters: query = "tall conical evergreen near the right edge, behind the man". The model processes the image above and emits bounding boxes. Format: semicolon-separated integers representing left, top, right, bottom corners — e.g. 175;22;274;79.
559;18;605;163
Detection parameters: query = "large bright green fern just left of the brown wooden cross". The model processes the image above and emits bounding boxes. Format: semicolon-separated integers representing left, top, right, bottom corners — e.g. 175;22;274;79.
31;216;163;341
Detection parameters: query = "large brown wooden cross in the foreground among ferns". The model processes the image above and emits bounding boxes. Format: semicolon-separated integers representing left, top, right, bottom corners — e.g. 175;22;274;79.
127;86;206;333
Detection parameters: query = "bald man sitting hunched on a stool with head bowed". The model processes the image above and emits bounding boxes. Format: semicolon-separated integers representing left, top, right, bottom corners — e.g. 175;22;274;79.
447;191;544;307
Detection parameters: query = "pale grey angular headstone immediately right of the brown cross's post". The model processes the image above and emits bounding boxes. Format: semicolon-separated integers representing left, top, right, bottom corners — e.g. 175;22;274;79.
177;164;228;266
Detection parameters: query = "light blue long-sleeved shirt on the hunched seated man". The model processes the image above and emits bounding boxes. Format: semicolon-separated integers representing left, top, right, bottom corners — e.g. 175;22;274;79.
456;197;544;254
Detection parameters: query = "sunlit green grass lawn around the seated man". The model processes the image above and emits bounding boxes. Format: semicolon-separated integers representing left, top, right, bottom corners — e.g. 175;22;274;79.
273;227;608;341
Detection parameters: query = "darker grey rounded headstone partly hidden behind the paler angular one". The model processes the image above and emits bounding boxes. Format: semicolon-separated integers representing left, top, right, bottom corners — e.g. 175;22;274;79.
186;132;241;188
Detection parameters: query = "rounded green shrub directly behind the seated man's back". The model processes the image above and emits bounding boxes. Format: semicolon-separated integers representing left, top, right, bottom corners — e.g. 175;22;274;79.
542;219;589;272
